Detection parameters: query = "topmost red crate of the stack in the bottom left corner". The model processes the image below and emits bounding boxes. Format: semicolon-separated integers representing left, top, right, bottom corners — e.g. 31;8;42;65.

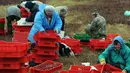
0;42;29;58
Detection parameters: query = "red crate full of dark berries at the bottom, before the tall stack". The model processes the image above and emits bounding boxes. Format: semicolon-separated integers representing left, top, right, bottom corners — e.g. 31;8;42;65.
31;60;62;73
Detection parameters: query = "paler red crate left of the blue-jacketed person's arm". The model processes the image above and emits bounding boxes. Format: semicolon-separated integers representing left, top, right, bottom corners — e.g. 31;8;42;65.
12;31;29;42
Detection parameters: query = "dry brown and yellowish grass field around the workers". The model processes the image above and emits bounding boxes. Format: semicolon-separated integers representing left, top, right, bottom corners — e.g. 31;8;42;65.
0;0;130;69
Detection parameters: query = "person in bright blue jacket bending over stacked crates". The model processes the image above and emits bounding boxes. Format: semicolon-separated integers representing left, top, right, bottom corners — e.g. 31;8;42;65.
28;5;62;49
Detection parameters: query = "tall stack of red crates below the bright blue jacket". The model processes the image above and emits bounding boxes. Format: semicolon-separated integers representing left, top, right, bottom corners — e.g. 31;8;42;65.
33;31;60;63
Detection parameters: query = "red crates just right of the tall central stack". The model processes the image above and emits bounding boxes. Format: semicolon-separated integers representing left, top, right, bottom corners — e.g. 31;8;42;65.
61;38;82;54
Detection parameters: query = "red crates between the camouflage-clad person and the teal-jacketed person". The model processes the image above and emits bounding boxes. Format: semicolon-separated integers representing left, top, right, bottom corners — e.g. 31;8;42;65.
89;34;119;50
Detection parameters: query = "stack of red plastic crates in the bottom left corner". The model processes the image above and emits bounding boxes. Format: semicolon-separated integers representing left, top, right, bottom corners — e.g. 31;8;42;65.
0;42;31;73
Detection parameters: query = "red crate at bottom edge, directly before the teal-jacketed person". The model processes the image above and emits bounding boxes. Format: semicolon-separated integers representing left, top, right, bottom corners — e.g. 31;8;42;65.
95;64;122;73
